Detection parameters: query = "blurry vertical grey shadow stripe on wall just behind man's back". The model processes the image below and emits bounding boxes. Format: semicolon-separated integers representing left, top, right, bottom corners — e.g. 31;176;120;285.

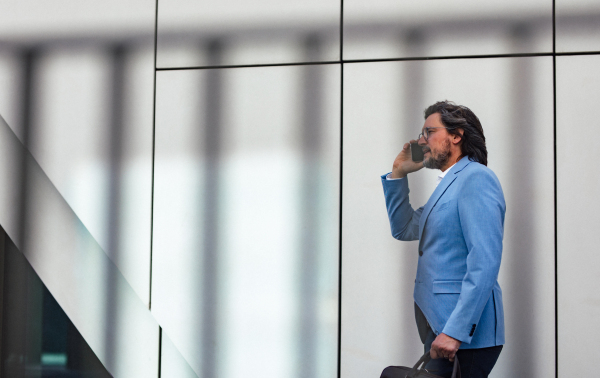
505;27;539;374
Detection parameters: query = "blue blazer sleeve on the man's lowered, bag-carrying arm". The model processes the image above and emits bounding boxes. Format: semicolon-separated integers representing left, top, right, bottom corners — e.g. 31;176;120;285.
442;169;506;343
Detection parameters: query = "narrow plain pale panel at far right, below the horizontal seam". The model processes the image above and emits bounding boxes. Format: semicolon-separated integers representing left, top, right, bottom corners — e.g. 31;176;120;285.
556;56;600;376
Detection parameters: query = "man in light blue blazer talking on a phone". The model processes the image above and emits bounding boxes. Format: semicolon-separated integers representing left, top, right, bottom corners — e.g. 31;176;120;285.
381;101;506;378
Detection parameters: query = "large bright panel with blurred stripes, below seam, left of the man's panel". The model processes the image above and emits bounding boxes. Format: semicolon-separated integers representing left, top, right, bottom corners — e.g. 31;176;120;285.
152;65;340;378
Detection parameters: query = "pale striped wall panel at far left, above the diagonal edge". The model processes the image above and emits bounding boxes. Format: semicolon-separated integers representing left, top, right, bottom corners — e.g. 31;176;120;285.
0;0;156;304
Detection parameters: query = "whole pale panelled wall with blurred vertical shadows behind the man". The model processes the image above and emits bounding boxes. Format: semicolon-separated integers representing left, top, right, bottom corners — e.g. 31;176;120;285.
0;0;600;378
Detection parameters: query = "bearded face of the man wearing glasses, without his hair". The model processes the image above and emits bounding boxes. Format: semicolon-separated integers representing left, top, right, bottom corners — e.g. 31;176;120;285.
418;113;450;169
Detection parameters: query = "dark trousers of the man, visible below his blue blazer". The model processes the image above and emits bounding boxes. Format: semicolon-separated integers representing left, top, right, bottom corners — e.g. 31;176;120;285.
415;303;502;378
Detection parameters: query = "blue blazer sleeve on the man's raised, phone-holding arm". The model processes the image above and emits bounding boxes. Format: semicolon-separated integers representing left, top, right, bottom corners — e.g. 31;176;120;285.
381;174;423;241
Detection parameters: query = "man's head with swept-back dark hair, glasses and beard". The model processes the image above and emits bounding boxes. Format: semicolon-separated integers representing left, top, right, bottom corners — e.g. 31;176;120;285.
419;101;487;170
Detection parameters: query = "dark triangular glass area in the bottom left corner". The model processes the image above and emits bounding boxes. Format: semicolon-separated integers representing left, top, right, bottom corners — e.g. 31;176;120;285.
0;229;111;378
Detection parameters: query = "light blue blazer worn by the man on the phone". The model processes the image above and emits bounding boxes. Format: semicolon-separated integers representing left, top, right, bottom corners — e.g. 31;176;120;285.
381;157;506;349
